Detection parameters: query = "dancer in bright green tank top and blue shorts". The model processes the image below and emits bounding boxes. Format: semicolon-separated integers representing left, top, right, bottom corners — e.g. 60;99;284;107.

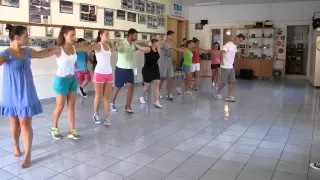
173;40;194;95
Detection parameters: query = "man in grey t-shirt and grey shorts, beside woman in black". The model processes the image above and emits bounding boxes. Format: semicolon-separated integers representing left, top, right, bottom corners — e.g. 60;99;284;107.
159;30;174;100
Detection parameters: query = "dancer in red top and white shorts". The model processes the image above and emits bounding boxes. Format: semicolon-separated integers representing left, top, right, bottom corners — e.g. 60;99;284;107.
191;39;211;90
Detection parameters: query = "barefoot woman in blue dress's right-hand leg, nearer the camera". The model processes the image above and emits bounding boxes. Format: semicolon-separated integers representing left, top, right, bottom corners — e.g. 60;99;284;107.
20;118;33;168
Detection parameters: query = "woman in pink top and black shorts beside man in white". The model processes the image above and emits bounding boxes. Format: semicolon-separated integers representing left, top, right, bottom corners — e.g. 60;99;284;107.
211;42;220;87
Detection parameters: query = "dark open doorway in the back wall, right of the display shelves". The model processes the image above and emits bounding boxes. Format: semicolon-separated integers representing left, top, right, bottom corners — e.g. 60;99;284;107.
285;25;309;76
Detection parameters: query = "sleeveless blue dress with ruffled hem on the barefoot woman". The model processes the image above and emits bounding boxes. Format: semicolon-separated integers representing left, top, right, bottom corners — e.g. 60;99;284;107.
0;48;43;118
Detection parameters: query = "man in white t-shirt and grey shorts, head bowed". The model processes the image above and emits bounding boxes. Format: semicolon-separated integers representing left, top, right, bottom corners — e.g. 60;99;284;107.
214;34;245;102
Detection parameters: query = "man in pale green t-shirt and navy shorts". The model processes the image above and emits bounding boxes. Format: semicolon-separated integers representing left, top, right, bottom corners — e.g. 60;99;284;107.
111;29;149;114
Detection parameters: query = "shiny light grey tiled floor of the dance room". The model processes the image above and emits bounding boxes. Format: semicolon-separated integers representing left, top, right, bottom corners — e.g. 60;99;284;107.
0;79;320;180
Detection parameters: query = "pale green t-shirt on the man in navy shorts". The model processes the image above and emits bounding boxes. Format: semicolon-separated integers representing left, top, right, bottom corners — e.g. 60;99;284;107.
116;40;136;69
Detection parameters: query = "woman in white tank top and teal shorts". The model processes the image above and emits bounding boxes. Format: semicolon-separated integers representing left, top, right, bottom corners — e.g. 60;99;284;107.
50;26;102;139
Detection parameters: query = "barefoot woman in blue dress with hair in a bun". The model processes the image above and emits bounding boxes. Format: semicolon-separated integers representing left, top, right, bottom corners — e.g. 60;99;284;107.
0;25;58;168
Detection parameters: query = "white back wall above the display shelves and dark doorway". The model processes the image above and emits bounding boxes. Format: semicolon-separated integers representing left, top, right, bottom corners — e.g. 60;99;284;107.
189;1;320;78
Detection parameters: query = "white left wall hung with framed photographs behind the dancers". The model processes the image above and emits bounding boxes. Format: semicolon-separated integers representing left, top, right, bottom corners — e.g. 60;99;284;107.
0;0;170;103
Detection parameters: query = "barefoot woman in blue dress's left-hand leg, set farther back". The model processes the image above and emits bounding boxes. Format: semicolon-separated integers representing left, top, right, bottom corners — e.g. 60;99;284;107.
9;117;21;157
